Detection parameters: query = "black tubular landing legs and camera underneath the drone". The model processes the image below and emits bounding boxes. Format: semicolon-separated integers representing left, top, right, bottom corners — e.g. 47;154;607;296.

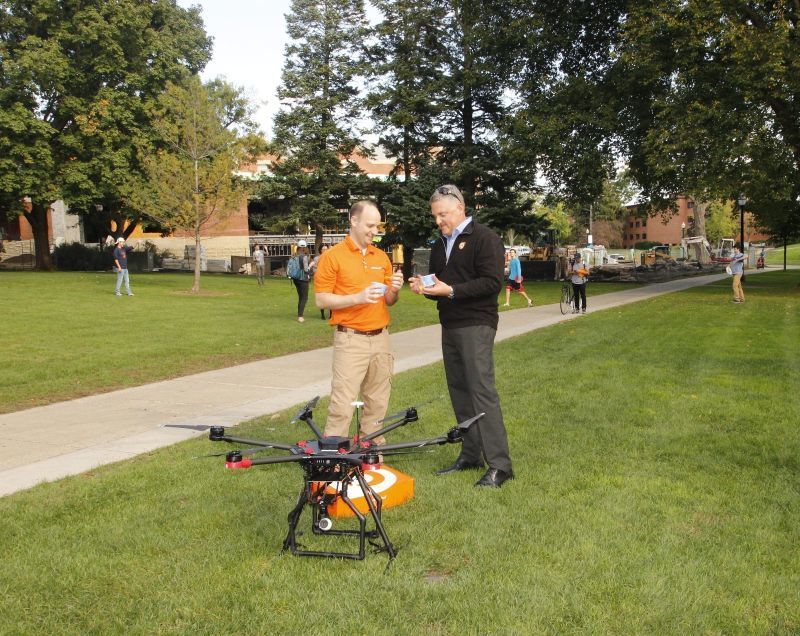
283;464;397;561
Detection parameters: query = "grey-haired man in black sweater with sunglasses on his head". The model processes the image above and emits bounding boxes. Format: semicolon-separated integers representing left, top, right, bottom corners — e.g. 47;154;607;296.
409;185;514;488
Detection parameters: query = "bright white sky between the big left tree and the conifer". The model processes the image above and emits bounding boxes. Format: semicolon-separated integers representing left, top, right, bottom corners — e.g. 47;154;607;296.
178;0;291;137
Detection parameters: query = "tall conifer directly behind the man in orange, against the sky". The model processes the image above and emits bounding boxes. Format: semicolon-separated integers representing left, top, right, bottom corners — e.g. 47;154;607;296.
258;0;367;247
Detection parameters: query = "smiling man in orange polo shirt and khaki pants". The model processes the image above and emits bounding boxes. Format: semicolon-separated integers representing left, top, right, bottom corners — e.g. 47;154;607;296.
314;201;403;444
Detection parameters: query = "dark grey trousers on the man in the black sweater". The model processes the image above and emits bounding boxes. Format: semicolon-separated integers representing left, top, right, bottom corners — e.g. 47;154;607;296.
442;325;511;472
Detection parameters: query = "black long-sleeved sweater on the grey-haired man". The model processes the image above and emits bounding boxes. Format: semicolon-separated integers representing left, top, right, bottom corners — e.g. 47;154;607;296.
429;221;505;329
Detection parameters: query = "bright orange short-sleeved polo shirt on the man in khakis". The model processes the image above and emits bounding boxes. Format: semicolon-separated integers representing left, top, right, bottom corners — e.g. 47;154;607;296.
314;236;392;331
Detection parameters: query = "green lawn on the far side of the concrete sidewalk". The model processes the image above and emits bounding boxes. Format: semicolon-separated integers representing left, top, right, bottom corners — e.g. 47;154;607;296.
0;272;630;413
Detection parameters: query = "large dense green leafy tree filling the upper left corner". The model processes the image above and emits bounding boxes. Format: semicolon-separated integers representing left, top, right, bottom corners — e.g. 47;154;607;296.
0;0;210;269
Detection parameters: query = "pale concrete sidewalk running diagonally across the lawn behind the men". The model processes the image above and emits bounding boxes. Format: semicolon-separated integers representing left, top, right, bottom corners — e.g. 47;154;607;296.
0;271;736;496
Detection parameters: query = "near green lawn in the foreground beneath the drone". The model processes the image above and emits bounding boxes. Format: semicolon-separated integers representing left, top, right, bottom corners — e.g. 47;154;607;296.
0;271;800;636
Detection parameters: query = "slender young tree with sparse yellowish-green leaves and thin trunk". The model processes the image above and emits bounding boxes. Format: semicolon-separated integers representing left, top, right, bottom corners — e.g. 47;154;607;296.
137;76;252;293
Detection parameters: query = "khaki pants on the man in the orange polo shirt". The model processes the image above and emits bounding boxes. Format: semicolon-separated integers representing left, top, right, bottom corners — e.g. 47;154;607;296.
325;329;394;444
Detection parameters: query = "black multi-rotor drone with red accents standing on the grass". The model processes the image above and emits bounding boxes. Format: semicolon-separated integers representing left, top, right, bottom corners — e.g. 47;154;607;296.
167;396;484;563
